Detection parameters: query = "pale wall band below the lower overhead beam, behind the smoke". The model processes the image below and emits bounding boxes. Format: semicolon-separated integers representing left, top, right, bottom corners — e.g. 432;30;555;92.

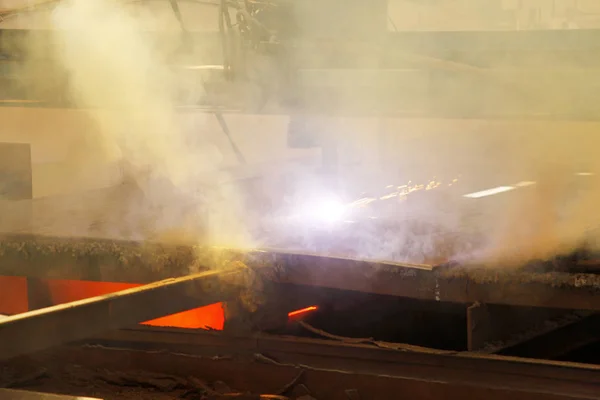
0;107;600;197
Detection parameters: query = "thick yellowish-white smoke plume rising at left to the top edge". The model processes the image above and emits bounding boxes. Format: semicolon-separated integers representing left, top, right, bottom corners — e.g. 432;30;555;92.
16;0;248;245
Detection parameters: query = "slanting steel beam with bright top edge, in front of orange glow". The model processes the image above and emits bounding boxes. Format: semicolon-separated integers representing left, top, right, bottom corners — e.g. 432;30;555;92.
0;267;247;360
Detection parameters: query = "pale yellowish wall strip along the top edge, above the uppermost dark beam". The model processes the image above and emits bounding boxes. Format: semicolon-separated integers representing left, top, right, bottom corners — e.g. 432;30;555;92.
0;0;600;32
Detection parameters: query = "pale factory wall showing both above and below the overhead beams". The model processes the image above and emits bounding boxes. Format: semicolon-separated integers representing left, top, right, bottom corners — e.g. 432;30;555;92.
0;0;600;203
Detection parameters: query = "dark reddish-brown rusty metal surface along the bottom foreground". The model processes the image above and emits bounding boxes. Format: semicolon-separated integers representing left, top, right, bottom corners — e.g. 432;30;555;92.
36;329;600;399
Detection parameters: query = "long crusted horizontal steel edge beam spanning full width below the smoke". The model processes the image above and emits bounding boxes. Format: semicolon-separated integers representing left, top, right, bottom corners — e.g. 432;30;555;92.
0;235;600;311
